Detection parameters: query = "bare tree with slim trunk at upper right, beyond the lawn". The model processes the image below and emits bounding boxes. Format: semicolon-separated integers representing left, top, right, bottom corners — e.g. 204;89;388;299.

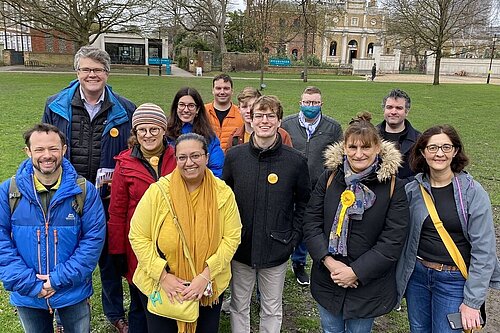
385;0;490;85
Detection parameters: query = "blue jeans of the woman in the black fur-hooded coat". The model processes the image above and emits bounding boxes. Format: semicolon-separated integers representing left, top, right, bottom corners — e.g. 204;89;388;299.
318;304;375;333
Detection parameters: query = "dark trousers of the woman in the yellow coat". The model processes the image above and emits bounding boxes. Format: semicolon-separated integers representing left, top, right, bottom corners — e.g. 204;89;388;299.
140;286;224;333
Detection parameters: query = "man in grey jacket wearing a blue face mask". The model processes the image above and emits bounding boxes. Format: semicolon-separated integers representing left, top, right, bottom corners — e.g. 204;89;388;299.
281;87;342;285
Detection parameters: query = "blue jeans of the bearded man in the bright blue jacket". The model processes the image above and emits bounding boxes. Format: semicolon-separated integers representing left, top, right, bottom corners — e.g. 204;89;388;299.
17;300;90;333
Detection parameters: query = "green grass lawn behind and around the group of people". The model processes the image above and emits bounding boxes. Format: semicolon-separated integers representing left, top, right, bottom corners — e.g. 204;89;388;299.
0;72;500;333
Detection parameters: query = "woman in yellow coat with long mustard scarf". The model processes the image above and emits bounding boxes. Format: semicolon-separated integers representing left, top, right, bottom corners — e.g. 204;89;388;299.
129;133;241;333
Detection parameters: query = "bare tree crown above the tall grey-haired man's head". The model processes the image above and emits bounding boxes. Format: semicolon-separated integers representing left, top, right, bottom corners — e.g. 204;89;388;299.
0;0;151;46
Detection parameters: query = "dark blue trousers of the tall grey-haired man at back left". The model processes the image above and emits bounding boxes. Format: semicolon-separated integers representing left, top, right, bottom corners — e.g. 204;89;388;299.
98;237;125;320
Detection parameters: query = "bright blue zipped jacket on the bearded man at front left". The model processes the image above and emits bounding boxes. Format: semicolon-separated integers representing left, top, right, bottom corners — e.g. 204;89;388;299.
0;159;106;309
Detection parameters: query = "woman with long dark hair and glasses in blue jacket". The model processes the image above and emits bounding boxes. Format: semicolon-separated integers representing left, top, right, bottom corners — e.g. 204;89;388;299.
167;87;224;178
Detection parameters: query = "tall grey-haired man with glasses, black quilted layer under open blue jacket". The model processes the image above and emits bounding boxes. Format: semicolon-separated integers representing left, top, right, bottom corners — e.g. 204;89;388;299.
42;46;135;333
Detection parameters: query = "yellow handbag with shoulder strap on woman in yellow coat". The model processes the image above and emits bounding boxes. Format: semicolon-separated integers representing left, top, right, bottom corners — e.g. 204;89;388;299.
148;183;200;323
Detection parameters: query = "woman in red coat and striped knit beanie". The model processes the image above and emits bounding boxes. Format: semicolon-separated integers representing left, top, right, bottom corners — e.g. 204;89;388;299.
108;103;176;333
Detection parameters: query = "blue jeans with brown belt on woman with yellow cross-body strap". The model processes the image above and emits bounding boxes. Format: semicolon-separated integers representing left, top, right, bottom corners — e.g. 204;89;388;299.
406;260;465;333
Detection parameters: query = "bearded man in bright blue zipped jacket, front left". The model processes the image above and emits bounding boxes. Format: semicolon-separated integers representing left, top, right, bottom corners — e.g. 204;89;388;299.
0;124;106;333
